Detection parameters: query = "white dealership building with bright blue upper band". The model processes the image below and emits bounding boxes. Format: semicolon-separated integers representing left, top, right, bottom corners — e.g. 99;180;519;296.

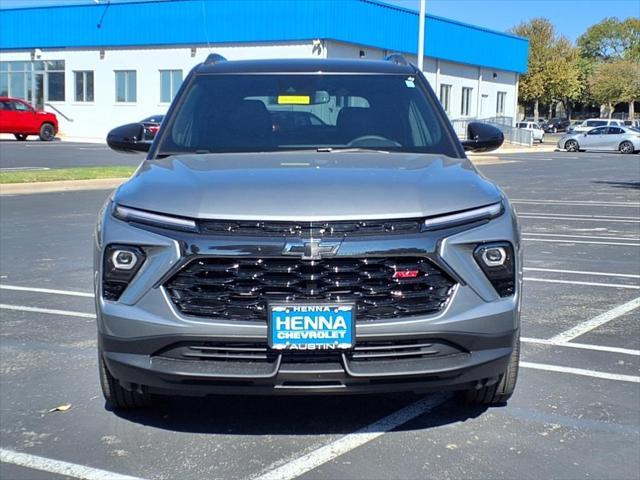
0;0;528;138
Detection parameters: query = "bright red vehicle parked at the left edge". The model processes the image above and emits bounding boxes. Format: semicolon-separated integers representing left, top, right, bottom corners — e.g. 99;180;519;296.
0;97;58;142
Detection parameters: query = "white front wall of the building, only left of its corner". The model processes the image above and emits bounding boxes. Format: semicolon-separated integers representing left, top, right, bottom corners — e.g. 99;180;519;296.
1;41;322;141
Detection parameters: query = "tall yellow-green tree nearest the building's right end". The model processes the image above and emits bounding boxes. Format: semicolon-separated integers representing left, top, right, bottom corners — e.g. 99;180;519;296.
511;18;581;119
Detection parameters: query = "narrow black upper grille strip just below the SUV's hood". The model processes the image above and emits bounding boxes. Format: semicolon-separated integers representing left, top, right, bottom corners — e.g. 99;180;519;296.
200;219;424;238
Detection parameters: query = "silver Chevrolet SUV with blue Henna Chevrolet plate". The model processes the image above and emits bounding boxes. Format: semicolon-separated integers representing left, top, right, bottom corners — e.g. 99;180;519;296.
95;55;521;408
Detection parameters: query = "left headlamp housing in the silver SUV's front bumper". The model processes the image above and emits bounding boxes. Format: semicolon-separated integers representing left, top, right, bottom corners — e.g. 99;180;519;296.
102;244;146;301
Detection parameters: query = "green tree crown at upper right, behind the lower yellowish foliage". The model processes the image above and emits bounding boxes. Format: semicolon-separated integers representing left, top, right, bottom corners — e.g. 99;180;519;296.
577;17;640;61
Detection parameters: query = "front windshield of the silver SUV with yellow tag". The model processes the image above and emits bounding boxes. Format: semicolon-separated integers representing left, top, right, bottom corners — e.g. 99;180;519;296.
156;74;459;157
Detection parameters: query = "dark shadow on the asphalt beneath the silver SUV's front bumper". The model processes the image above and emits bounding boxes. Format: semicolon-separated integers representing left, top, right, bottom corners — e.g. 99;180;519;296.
113;393;487;435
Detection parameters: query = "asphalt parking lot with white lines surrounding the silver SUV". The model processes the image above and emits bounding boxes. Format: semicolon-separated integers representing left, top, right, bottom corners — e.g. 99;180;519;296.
0;143;640;479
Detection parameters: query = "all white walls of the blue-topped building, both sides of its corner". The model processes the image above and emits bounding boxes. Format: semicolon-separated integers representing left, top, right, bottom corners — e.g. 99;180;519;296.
1;40;517;140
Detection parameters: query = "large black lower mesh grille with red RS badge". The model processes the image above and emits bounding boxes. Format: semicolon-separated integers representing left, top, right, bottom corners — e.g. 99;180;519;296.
164;257;454;322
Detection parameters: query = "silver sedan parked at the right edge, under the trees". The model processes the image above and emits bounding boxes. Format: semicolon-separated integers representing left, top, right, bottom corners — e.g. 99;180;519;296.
558;126;640;153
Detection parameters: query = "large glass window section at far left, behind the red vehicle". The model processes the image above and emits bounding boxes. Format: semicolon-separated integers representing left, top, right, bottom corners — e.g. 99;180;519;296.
0;60;65;108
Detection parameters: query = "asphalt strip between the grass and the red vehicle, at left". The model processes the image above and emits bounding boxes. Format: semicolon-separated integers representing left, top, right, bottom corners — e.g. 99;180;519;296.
0;140;144;171
